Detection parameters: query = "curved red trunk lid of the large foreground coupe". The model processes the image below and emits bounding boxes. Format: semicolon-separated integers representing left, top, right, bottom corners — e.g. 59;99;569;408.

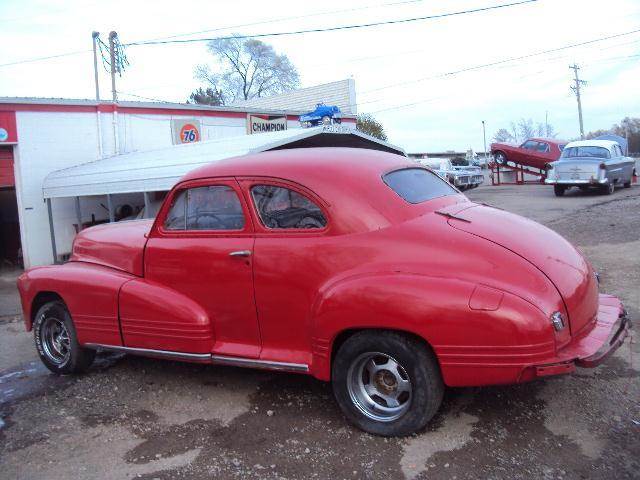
440;203;598;334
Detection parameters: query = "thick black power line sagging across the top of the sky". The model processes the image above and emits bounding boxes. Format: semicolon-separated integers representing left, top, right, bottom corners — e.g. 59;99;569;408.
124;0;538;46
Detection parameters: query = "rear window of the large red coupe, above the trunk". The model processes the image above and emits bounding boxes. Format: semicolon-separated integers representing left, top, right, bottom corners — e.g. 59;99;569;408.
382;168;458;203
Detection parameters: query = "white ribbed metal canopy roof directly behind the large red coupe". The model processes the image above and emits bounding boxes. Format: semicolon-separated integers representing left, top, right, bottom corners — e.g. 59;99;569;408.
42;126;405;198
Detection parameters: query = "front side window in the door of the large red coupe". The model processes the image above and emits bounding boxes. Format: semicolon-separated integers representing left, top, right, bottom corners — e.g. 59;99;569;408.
164;185;245;230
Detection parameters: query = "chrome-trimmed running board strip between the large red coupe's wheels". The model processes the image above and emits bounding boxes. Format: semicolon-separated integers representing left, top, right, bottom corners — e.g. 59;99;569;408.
84;343;309;372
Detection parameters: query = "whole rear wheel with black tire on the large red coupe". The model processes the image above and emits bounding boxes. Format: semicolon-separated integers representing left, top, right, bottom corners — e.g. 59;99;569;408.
331;330;444;436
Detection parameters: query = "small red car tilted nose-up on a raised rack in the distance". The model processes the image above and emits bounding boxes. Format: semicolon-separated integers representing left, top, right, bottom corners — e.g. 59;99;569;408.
491;138;568;170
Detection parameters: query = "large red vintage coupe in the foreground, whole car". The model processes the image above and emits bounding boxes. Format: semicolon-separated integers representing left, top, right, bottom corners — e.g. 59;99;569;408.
18;148;628;435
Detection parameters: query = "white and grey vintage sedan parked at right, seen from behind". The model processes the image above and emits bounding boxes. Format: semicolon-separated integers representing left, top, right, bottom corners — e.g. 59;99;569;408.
545;140;635;197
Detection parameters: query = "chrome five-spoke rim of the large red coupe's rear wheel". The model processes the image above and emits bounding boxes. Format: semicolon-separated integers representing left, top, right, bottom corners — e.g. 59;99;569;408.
347;352;413;422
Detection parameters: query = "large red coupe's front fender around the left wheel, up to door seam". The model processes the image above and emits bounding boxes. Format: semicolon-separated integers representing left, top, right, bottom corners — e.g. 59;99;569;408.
18;262;136;345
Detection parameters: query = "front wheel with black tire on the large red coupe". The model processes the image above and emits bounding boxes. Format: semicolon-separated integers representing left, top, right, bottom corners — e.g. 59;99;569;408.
33;301;96;375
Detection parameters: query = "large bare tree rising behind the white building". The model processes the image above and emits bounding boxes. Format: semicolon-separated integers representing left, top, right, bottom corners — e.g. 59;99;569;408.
195;35;300;101
